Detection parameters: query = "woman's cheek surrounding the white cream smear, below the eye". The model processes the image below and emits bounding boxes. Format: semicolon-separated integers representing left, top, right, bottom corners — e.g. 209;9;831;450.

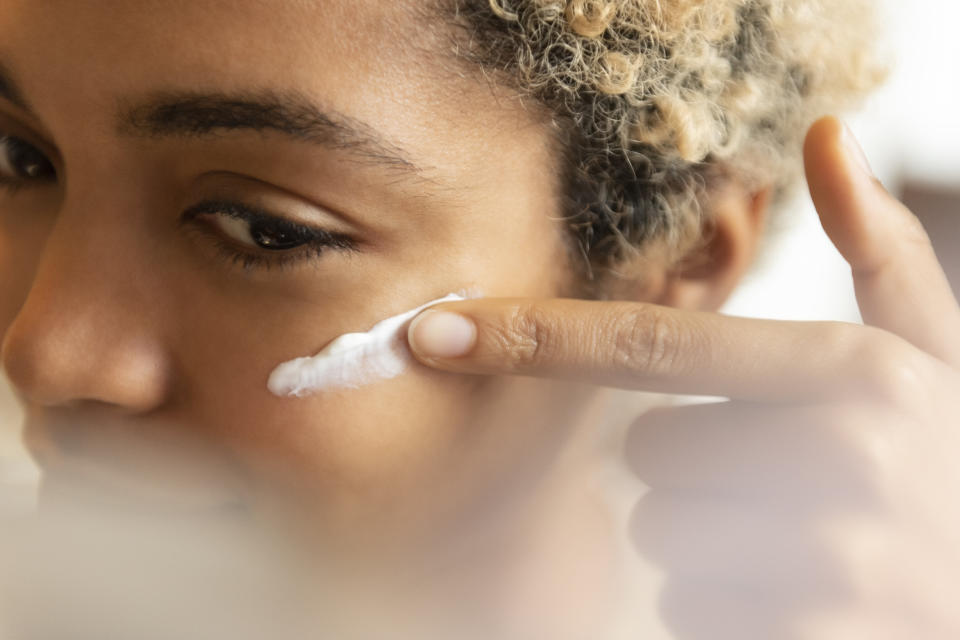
158;179;565;538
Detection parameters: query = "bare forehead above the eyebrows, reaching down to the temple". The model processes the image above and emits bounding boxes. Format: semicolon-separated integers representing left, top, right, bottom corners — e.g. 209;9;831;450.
0;0;550;202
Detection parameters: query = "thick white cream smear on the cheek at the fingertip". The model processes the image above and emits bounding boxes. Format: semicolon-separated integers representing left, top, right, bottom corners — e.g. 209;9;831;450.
267;293;466;398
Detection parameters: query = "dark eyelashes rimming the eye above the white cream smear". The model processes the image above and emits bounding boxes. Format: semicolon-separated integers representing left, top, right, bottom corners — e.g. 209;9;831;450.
180;200;357;271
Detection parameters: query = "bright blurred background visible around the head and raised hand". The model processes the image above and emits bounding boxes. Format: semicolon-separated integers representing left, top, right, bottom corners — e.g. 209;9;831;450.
0;0;960;515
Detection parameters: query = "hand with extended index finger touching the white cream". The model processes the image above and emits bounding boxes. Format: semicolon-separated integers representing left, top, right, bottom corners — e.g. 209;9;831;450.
410;118;960;640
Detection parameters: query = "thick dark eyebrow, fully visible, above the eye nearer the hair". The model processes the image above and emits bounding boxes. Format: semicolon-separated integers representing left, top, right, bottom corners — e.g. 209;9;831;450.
117;91;422;174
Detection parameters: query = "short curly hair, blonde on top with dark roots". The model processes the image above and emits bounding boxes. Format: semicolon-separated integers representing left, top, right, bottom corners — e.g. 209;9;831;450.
447;0;884;288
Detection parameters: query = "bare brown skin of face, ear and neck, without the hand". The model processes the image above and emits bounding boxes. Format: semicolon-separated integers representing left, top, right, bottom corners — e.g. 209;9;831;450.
0;0;759;637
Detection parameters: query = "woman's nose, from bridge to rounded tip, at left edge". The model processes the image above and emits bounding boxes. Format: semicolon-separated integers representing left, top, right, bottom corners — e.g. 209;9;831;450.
0;190;169;411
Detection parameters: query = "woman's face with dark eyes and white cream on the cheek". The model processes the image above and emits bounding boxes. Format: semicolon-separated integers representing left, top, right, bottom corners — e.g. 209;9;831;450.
0;0;566;548
